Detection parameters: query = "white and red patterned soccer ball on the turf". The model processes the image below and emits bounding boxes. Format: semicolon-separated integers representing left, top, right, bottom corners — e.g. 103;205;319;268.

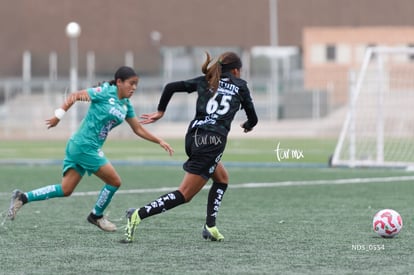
372;209;403;238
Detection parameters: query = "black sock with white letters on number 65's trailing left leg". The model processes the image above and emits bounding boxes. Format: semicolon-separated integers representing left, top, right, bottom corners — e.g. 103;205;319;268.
138;190;185;220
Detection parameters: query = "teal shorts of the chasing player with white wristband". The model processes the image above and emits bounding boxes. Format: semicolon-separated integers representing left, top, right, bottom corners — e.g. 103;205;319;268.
63;139;108;176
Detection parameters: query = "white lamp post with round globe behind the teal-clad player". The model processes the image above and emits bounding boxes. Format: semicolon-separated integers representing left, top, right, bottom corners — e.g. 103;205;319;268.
65;22;81;133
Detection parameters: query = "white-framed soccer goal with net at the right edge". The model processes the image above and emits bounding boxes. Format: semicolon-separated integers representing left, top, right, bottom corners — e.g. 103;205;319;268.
331;47;414;167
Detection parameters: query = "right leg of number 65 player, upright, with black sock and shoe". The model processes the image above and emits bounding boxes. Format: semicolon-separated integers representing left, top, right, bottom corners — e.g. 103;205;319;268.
202;161;229;241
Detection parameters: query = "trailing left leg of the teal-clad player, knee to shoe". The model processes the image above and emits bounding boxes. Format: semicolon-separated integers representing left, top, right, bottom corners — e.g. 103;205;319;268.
8;169;82;220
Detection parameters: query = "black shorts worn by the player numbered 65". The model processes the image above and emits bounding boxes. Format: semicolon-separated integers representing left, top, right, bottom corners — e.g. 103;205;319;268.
183;129;227;179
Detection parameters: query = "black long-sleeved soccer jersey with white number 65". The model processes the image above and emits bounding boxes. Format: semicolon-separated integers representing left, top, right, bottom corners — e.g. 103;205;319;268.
158;73;257;136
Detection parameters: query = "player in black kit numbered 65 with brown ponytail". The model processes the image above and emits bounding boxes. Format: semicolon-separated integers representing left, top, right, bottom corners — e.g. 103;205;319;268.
123;52;257;243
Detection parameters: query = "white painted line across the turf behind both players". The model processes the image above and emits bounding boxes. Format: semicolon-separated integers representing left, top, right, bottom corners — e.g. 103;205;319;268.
0;176;414;196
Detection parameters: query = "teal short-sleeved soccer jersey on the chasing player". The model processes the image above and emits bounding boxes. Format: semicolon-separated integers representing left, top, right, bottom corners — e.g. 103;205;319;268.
71;82;135;148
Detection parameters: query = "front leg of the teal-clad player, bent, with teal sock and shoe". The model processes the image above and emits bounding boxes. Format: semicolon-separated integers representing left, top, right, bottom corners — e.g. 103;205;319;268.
87;162;121;232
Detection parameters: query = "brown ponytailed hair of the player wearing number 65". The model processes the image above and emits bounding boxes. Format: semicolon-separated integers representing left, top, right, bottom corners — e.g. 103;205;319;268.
201;52;242;93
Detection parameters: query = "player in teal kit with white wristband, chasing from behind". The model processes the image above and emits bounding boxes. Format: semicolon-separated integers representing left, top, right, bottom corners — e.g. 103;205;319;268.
8;66;173;231
